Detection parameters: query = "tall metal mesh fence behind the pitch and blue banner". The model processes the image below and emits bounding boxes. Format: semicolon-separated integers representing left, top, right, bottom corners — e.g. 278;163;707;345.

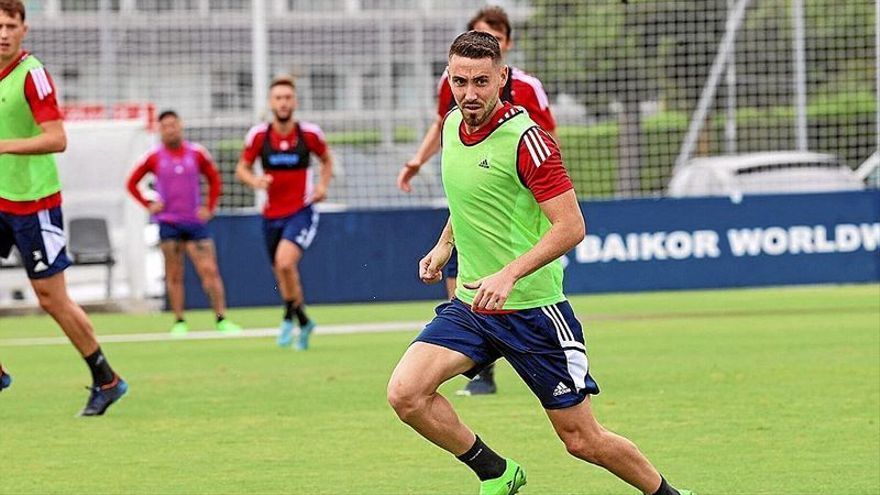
26;0;880;209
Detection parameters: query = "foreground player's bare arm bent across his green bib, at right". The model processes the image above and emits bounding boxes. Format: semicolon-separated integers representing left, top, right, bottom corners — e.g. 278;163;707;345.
464;189;586;310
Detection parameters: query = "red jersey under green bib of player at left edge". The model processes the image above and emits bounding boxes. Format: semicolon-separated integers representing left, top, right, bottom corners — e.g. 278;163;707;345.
0;52;62;215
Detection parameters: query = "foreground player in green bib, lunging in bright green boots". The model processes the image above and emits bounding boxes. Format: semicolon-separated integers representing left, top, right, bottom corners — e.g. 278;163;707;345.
388;31;690;495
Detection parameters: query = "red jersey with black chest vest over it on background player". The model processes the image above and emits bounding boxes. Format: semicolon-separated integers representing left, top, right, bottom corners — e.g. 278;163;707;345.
241;122;328;218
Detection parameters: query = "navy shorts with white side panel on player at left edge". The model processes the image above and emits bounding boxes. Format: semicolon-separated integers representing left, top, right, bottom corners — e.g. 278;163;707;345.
0;206;70;279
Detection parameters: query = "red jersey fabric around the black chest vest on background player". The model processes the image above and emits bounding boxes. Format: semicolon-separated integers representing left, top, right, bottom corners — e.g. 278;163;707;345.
241;121;328;218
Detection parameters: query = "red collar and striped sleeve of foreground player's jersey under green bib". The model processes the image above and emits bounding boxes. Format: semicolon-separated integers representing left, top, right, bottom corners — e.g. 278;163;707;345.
458;102;574;203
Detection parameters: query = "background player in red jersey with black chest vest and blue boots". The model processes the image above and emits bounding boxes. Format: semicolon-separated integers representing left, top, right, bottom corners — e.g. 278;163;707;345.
235;76;333;350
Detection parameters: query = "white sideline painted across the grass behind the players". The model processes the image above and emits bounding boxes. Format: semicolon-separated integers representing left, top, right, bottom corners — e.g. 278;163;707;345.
0;321;426;347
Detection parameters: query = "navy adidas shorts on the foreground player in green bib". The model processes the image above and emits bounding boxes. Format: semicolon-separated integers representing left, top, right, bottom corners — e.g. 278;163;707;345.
415;298;599;409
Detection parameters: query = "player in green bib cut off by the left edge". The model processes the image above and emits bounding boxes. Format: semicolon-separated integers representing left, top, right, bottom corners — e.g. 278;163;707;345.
0;0;128;416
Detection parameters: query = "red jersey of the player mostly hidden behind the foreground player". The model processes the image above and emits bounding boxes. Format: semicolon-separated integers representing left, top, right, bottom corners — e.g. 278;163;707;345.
437;65;556;136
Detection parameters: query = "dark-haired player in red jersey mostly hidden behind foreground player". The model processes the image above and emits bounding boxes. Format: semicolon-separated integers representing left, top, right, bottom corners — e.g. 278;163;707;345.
397;6;558;395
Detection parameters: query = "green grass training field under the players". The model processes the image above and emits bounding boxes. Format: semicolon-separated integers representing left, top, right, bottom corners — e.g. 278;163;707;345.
0;285;880;495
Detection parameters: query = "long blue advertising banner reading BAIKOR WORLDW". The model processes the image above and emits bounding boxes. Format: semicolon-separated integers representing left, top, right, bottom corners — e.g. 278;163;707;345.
186;190;880;307
